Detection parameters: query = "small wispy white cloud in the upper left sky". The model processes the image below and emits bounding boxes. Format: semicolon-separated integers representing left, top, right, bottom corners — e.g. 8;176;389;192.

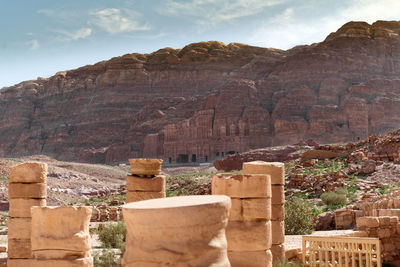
89;8;150;34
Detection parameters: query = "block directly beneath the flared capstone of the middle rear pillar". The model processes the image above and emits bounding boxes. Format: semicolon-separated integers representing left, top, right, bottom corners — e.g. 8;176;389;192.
126;175;166;192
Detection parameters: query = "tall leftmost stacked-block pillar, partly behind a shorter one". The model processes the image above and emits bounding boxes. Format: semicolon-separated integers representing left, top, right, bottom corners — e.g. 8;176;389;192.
7;162;47;267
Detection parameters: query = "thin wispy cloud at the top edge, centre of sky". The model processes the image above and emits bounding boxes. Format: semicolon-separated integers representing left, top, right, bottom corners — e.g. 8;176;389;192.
158;0;286;26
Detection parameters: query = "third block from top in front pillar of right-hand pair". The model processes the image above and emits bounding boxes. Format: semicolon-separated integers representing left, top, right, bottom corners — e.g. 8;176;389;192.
226;221;272;251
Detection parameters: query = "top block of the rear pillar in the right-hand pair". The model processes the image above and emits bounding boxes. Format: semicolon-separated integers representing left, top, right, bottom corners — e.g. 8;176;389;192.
243;161;285;185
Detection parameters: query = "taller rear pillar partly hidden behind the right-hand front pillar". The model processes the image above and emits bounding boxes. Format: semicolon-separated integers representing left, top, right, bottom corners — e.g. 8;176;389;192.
243;161;285;262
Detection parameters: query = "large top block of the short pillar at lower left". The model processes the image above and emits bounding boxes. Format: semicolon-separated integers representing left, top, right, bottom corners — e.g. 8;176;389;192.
31;207;92;251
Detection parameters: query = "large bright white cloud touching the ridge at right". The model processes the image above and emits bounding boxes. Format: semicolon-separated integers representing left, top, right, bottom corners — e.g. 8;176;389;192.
247;0;400;49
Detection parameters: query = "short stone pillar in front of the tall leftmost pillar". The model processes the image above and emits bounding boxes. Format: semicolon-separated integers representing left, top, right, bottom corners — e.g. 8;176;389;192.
31;207;93;267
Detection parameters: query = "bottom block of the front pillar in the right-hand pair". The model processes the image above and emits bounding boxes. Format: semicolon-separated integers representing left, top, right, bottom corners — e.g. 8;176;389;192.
228;250;272;267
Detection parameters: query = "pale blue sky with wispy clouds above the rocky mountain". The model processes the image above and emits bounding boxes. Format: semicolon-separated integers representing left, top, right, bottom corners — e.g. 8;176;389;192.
0;0;400;88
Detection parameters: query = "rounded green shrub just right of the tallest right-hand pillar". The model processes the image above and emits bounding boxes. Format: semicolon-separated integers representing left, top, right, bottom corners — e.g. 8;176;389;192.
285;198;316;235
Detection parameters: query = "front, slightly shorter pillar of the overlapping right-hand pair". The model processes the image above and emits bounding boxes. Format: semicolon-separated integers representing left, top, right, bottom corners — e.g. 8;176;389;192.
211;174;272;267
